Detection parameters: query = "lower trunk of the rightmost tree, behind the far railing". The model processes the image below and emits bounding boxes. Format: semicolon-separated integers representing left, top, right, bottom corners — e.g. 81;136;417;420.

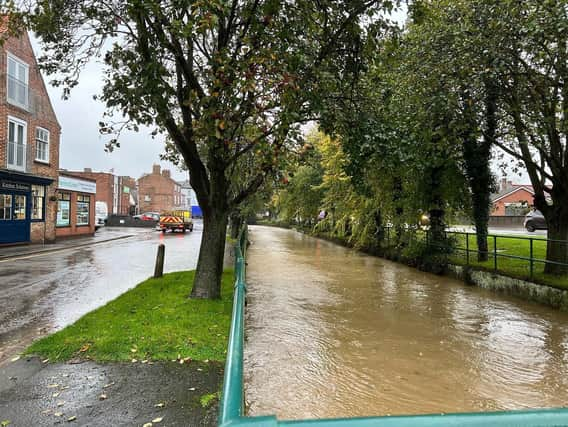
544;209;568;275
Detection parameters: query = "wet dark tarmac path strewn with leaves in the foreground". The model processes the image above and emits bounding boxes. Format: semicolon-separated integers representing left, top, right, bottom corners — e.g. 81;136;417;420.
0;357;223;427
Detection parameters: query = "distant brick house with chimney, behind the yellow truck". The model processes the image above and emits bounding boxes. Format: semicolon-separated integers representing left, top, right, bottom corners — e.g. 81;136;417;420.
138;165;182;212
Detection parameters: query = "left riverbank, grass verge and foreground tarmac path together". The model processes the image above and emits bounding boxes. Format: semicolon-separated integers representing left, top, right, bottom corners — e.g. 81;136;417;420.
0;271;234;426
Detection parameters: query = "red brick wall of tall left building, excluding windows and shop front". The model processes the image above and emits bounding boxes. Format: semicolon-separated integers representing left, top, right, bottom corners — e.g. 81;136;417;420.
0;30;61;242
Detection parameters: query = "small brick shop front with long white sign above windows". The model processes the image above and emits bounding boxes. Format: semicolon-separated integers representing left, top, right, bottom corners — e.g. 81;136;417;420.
56;174;97;238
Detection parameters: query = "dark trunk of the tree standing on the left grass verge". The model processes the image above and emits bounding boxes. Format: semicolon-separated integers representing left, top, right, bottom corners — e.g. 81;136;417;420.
190;209;228;299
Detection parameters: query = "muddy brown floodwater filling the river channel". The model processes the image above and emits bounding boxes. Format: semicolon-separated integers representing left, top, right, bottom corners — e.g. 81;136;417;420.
245;226;568;419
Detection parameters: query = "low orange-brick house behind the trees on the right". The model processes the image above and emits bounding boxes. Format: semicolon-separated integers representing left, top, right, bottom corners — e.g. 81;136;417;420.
491;178;534;216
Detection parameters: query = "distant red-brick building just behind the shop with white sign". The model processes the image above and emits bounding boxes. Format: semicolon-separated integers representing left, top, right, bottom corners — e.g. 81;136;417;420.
65;168;136;215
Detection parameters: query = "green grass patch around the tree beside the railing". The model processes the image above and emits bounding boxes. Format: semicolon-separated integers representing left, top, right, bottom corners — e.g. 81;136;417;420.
26;271;234;362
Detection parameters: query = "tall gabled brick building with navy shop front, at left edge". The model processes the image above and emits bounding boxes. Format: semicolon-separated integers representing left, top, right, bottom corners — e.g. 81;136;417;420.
0;24;61;244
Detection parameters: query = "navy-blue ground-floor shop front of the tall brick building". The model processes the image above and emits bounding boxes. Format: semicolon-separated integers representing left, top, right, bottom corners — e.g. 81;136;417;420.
0;171;53;245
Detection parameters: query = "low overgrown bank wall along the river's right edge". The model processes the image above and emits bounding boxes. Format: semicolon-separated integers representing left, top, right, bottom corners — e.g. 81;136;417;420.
259;223;568;311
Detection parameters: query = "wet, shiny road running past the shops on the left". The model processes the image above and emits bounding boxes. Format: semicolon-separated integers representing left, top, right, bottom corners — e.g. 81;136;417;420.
0;223;202;364
